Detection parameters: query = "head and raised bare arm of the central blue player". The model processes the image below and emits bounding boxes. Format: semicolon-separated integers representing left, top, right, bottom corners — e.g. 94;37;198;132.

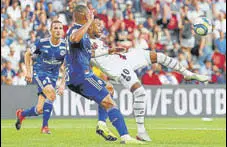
70;5;94;43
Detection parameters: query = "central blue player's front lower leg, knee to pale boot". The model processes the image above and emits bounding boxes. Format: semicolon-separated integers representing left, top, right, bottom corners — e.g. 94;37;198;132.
100;95;144;144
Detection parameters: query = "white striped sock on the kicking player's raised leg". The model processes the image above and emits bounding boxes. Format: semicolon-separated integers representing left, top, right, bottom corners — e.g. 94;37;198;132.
157;53;193;76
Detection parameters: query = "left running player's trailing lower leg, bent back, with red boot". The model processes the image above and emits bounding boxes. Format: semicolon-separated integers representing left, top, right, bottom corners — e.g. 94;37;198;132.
15;95;45;130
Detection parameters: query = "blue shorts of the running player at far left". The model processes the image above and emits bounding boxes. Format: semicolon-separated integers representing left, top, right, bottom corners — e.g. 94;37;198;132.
33;74;57;95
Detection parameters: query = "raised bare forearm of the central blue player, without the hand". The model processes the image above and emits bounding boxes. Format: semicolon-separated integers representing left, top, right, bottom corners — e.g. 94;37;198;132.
70;20;93;43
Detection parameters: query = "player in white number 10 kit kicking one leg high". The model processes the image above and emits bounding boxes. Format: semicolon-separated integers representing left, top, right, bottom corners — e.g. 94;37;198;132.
88;19;208;141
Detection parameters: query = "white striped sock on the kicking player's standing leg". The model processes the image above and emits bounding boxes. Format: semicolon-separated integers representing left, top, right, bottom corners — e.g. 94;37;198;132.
133;87;146;133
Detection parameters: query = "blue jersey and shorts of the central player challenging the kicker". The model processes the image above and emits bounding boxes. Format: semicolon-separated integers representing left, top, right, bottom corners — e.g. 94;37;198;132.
65;24;109;104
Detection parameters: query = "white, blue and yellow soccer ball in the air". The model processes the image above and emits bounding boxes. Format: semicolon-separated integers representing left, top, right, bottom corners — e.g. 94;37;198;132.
193;17;212;36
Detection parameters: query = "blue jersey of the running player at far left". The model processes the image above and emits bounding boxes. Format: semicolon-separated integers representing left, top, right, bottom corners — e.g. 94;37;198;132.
31;38;66;80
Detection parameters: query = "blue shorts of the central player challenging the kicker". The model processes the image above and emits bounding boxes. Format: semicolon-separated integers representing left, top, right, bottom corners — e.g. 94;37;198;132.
68;74;109;104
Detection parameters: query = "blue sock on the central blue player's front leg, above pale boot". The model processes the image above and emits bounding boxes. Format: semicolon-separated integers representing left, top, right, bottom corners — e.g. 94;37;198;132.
107;107;128;136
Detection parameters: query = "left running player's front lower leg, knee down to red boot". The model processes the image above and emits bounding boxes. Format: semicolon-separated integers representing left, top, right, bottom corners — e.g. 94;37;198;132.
41;85;56;134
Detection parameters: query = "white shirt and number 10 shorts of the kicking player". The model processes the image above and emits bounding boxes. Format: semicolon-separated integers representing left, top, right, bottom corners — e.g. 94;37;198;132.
90;38;151;89
